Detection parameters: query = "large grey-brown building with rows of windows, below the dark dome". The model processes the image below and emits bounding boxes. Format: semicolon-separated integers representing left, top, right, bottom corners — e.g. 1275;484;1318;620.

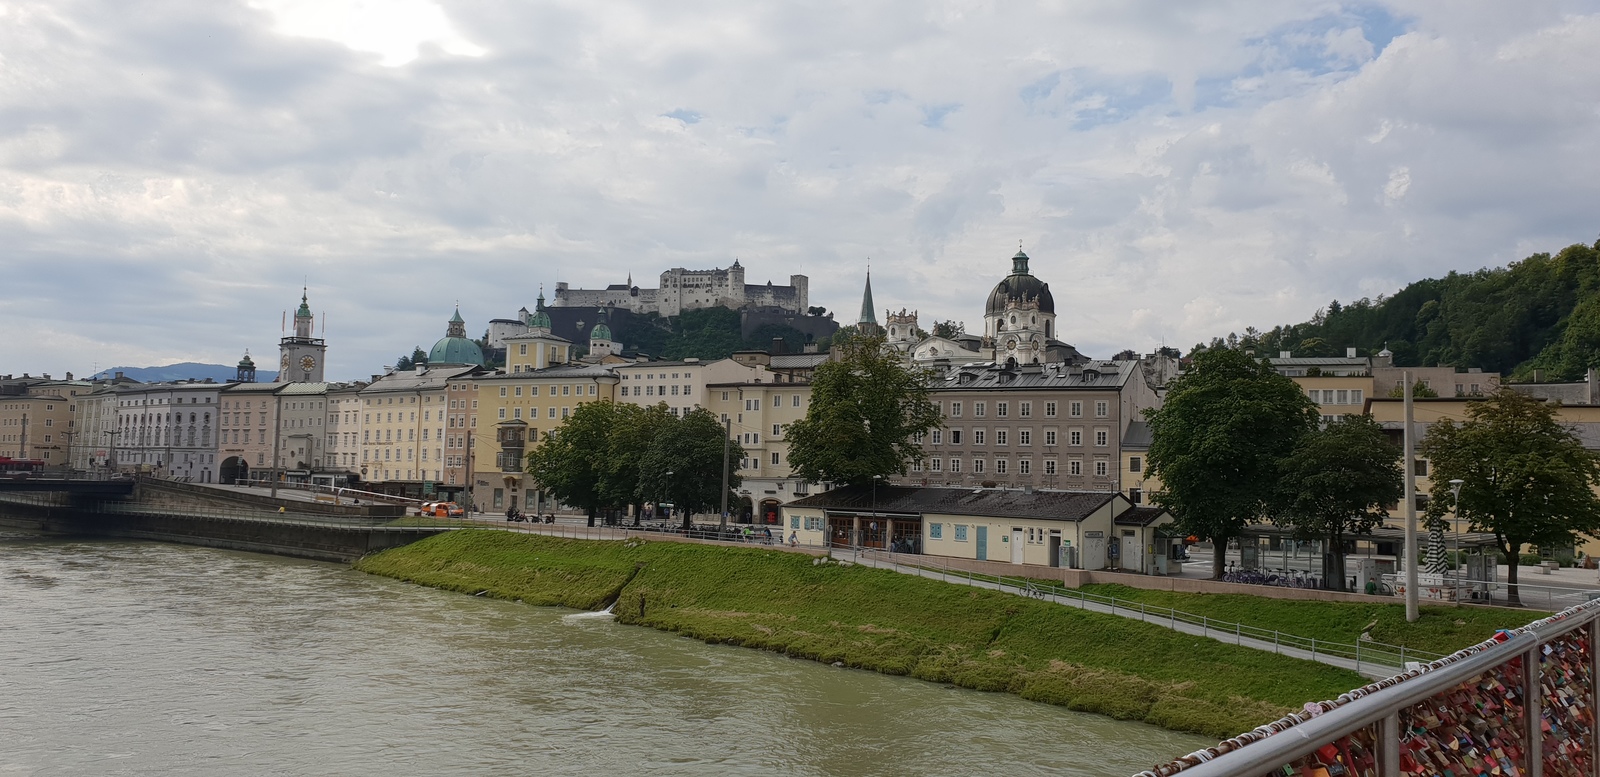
891;361;1158;491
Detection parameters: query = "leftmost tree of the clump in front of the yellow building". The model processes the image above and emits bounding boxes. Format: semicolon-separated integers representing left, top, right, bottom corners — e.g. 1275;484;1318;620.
526;401;619;521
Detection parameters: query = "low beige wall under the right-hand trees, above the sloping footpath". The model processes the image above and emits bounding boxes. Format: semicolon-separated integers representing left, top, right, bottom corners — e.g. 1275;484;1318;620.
867;552;1395;604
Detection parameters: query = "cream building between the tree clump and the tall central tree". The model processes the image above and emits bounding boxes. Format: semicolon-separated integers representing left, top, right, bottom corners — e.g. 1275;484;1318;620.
706;381;821;524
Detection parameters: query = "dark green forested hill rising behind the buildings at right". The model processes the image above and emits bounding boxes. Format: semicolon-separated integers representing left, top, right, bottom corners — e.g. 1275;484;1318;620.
1211;243;1600;381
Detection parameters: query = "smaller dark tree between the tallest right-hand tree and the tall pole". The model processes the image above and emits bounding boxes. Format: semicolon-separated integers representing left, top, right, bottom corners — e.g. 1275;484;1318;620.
1272;416;1405;592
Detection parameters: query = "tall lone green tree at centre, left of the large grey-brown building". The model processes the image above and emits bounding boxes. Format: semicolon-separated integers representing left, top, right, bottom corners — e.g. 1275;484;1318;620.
789;329;944;484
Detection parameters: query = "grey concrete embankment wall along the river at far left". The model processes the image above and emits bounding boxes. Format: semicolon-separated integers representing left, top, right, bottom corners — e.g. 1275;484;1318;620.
0;502;443;561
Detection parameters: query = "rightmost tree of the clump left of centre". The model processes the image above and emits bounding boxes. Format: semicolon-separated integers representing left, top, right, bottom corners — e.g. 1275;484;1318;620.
638;409;744;528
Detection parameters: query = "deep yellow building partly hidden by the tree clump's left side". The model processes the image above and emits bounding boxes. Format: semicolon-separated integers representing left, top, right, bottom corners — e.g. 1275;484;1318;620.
467;364;621;515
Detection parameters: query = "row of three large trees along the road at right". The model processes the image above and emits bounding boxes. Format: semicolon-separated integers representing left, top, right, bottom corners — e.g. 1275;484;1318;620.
1146;349;1600;601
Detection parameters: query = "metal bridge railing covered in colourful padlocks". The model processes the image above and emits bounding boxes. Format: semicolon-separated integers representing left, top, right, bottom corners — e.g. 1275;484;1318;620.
1136;601;1600;777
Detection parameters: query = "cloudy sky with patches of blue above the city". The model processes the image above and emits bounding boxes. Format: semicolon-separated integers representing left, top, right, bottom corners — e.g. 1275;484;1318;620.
0;0;1600;379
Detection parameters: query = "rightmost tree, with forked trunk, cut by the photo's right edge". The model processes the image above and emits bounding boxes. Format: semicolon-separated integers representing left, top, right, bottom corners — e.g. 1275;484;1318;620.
1421;389;1600;604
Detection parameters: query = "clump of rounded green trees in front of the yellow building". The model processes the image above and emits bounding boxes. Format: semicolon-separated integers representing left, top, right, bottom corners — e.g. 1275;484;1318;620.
526;401;744;524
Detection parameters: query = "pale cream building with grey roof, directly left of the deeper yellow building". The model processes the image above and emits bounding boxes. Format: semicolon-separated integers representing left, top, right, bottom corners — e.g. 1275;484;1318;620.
358;365;483;497
